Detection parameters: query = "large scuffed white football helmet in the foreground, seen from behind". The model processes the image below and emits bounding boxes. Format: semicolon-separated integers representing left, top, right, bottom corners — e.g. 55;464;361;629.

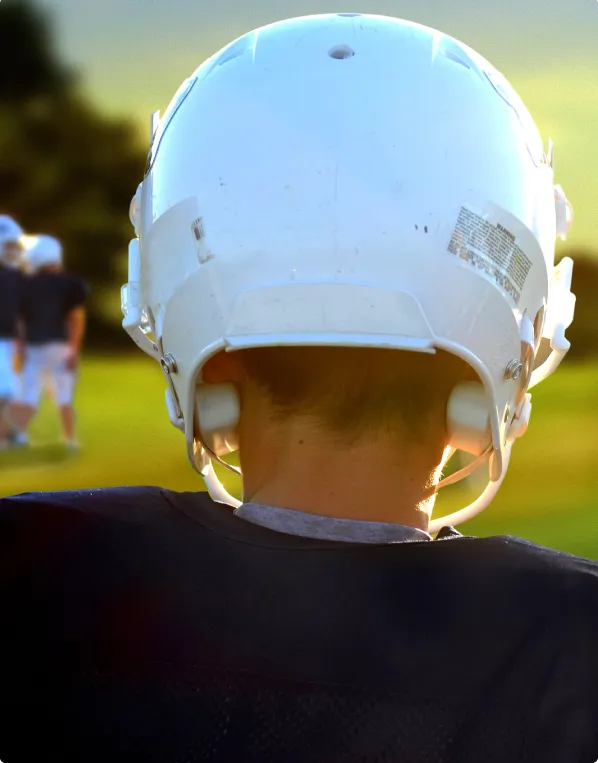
123;14;574;532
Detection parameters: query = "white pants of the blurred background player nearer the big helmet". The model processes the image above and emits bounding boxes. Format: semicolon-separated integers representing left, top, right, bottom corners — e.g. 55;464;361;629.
19;342;76;408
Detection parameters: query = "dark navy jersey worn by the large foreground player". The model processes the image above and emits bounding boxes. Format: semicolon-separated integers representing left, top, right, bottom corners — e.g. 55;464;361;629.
0;488;598;763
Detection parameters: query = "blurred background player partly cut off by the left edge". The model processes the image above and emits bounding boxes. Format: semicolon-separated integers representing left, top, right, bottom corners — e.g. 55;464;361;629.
0;215;23;448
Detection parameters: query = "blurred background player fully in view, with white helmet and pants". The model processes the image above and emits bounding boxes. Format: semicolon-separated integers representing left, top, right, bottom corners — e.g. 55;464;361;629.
11;235;87;449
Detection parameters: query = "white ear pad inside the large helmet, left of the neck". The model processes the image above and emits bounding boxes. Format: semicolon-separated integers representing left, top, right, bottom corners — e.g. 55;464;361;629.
195;384;241;456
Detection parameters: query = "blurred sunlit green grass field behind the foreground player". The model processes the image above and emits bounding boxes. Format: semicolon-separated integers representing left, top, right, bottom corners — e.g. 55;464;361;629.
0;358;598;559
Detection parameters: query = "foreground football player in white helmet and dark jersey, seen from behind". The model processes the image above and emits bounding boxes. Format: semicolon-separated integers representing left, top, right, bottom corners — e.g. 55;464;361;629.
0;14;598;763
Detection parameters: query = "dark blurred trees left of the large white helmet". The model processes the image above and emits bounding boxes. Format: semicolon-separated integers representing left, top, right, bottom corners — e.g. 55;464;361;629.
0;2;146;347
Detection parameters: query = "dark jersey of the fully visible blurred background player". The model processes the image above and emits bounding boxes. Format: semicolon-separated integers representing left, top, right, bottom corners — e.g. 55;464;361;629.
21;271;87;344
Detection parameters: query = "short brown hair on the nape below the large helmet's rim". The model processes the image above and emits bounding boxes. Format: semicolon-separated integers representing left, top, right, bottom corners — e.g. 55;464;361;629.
241;347;472;444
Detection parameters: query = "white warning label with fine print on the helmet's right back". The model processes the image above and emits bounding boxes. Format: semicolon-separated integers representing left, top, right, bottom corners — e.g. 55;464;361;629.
448;207;532;305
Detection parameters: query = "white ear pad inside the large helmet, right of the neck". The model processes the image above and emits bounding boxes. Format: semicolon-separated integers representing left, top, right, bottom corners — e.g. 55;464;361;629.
446;382;492;456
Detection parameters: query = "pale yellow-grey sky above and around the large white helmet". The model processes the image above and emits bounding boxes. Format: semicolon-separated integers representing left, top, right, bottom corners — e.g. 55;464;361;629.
35;0;598;253
